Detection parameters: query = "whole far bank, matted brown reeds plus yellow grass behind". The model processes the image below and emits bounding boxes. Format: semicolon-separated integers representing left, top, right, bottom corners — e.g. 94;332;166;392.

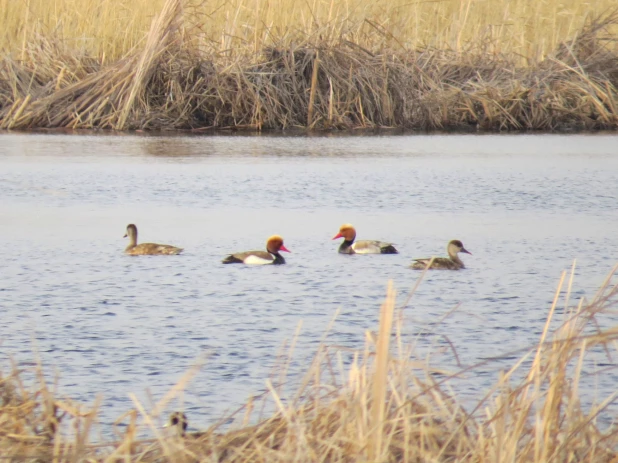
0;0;618;131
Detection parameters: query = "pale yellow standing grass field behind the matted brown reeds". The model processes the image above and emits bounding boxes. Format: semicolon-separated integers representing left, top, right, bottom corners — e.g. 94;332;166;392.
0;0;616;60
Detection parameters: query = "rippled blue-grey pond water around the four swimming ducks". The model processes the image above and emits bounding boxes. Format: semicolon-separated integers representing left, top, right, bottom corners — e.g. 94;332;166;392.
0;133;618;434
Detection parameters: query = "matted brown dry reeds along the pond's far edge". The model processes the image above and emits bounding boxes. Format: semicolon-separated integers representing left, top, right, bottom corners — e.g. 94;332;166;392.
0;0;618;131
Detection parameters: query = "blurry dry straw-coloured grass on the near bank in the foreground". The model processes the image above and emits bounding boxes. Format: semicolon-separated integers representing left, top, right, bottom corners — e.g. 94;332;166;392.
0;269;618;463
